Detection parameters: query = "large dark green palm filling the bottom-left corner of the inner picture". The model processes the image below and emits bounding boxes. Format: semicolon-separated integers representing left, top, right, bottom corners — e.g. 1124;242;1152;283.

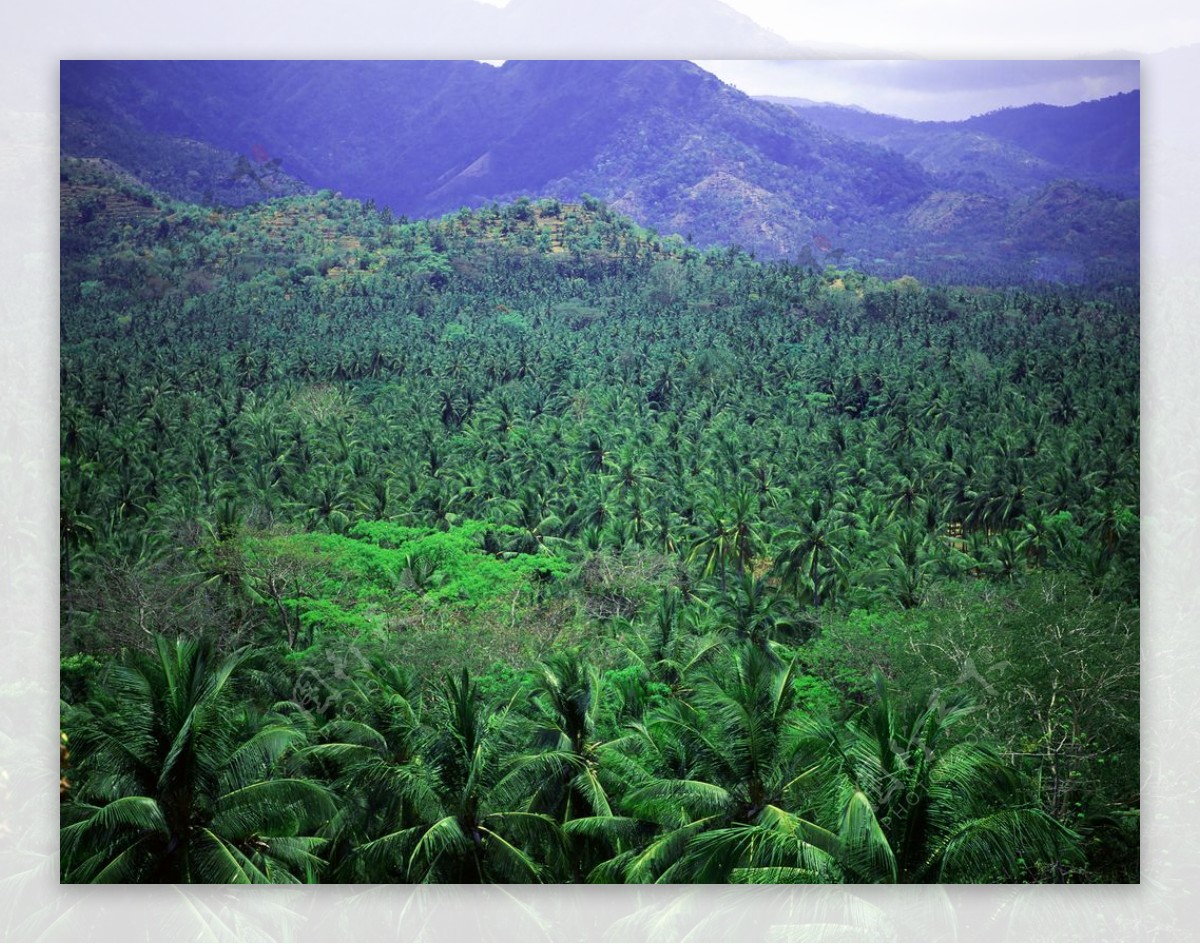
61;637;335;884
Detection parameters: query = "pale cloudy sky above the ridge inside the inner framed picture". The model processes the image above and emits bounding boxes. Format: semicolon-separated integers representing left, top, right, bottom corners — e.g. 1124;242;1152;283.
697;59;1140;121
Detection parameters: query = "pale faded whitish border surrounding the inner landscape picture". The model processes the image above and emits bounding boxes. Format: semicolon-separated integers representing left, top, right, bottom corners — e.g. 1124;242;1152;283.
0;0;1200;940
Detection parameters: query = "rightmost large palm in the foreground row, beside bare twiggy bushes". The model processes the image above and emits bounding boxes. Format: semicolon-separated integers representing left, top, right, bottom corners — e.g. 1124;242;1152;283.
810;674;1078;883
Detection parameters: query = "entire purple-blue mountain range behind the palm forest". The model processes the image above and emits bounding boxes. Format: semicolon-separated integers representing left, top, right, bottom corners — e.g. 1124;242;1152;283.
61;56;1136;279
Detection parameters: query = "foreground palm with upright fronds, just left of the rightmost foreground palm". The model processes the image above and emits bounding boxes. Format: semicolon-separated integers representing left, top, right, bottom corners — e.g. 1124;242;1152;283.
595;645;839;882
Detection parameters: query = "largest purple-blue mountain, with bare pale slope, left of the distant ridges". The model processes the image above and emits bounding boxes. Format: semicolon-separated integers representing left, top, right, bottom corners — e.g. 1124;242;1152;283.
62;60;928;247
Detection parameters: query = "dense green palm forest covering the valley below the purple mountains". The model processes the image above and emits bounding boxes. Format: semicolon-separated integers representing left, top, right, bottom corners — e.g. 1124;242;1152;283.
60;160;1139;883
